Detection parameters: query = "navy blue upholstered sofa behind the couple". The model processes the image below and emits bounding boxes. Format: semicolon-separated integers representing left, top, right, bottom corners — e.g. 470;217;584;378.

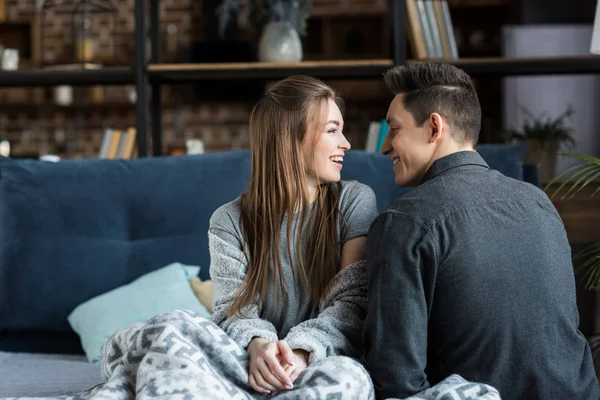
0;145;537;397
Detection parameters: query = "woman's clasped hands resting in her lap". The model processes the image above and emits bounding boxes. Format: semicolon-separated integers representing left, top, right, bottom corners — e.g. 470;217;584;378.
248;338;309;395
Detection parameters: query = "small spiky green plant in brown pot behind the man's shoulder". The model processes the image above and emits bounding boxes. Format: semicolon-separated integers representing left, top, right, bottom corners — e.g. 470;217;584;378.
505;105;575;183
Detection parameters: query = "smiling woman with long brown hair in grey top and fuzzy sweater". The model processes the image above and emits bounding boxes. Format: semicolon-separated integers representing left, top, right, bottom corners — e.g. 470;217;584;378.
209;76;377;399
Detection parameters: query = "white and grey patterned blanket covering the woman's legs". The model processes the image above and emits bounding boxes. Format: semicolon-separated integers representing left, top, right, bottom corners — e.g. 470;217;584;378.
3;310;500;400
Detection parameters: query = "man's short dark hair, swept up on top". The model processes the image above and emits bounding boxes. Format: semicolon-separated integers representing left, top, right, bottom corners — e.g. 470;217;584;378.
384;63;481;146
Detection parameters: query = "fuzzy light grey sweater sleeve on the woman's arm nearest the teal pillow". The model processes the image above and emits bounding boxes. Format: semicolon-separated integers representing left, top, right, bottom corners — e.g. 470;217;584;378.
208;211;277;349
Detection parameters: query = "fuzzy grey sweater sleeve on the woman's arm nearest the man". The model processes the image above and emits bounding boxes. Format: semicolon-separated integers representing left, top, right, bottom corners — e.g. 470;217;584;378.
285;261;368;364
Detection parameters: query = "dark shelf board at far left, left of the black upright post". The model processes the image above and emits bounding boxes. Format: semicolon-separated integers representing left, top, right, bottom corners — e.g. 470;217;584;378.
0;67;134;87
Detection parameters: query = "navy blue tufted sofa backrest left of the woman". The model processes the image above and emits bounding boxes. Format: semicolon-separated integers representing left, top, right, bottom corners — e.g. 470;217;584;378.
0;150;250;332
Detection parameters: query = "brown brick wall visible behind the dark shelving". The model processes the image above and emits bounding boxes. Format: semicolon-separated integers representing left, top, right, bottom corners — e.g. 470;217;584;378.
0;0;388;158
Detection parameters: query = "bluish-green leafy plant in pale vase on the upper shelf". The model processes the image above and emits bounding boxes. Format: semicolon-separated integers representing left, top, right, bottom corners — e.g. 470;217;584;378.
217;0;312;62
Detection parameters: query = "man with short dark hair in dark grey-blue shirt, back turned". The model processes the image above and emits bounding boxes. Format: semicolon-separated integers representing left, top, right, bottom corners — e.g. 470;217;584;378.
363;63;600;400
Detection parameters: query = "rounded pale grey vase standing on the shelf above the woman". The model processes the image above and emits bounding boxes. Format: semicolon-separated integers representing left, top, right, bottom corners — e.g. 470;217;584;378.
258;21;302;63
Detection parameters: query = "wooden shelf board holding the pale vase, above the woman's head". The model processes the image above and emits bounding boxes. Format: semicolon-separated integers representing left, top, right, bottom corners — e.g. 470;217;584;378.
148;60;392;83
